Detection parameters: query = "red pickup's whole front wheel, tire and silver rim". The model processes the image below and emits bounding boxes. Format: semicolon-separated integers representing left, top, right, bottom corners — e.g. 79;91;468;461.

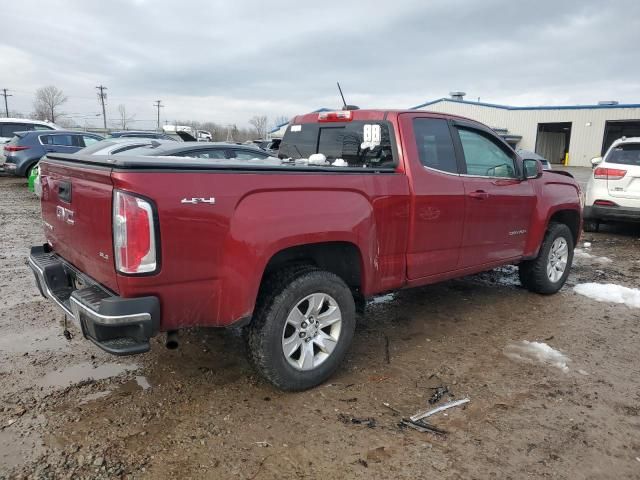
518;223;574;295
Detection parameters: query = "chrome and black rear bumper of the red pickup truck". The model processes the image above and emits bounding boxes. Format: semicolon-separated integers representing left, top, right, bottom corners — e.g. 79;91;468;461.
29;245;160;355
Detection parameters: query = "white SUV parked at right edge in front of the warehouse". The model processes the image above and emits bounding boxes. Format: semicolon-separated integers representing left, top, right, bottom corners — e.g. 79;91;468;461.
584;137;640;231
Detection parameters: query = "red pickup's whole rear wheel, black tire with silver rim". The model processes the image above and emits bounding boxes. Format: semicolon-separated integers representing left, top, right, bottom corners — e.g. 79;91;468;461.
248;267;355;390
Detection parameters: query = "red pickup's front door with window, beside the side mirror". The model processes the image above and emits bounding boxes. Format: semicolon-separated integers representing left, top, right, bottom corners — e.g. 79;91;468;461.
455;123;536;268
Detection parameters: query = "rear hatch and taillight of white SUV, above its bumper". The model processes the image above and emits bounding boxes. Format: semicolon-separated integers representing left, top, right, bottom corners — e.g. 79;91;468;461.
599;143;640;202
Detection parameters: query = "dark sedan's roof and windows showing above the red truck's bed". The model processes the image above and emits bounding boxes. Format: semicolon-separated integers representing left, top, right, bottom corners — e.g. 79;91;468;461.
119;142;270;160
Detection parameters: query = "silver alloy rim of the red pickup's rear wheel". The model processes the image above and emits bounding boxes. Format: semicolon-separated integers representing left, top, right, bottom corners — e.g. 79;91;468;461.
282;293;342;371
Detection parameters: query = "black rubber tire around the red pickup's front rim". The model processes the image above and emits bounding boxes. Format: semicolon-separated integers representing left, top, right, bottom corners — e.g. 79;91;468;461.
518;223;574;295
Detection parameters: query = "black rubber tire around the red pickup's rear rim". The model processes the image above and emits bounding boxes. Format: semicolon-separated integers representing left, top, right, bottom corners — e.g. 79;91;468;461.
247;265;356;391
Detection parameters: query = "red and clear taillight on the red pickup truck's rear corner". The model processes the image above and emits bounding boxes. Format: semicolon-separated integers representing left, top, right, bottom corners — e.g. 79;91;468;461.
113;190;157;274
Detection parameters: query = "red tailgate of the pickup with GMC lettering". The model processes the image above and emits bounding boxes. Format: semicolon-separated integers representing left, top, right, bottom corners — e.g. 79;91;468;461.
40;159;118;292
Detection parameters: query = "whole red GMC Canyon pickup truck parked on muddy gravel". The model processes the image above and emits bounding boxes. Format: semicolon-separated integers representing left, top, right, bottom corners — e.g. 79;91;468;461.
29;110;582;390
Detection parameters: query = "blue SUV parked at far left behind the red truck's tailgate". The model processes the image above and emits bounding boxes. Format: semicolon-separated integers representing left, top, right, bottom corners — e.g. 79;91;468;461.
3;130;103;177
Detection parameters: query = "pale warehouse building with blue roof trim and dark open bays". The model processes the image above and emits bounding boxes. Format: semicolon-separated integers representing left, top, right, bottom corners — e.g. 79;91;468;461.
412;92;640;167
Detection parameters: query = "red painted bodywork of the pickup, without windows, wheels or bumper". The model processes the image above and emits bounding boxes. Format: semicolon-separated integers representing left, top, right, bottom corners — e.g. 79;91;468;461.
41;110;580;330
